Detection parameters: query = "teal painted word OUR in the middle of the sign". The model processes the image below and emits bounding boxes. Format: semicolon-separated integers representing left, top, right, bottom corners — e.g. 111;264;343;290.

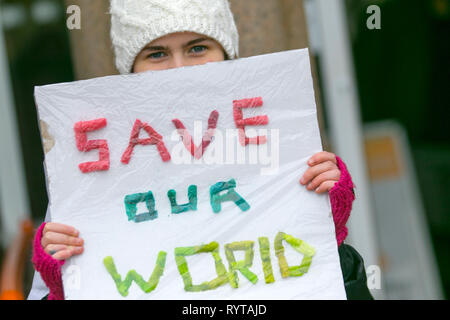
125;179;250;223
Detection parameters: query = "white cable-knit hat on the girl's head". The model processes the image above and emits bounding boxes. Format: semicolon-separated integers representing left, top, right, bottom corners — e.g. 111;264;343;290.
110;0;239;74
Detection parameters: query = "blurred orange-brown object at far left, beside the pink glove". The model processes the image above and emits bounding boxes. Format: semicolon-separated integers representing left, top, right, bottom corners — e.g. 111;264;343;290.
0;220;34;300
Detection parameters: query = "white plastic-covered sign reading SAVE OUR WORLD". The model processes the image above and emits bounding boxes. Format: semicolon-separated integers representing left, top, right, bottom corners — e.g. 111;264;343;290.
35;49;346;300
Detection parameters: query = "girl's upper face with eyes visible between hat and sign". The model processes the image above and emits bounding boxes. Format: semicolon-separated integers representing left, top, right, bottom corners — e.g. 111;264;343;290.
132;32;226;73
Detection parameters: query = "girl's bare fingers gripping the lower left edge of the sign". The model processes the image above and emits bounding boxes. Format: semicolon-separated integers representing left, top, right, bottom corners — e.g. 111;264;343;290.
41;222;84;260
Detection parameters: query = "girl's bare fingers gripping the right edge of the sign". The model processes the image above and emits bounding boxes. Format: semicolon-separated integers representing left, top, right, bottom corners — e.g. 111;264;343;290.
300;151;341;193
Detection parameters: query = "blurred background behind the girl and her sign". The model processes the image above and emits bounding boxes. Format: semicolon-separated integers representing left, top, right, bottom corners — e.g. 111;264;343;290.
0;0;450;299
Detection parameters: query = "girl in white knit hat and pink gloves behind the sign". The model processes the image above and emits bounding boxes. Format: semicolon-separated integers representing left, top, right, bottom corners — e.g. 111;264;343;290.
30;0;371;299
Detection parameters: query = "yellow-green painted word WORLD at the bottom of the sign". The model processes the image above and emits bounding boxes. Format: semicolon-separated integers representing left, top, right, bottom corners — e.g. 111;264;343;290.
103;232;315;297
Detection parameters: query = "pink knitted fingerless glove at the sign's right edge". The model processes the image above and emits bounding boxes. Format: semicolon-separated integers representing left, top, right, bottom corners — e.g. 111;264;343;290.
329;156;355;246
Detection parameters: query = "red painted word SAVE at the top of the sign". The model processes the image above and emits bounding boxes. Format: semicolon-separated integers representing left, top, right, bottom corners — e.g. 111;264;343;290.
74;97;269;173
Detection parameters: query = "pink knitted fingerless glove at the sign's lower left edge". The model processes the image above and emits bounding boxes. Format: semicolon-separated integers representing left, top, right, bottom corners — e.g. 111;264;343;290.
32;222;65;300
